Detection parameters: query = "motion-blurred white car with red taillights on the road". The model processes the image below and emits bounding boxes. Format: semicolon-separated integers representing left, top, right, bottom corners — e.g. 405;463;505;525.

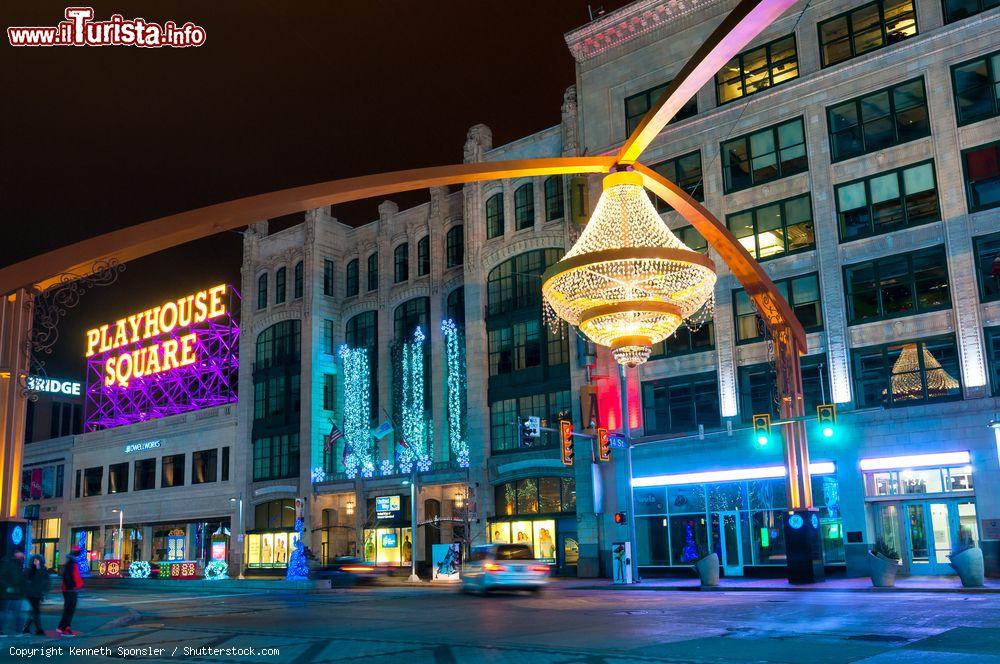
462;544;549;593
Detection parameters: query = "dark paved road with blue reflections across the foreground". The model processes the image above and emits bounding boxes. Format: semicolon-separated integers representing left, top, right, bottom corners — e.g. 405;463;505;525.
3;588;1000;664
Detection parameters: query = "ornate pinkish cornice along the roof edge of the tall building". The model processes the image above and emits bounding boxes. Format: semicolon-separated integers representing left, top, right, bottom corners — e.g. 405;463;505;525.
564;0;725;62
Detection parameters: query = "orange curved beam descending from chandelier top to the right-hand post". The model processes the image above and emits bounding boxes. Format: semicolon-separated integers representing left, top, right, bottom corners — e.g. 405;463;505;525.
632;163;806;353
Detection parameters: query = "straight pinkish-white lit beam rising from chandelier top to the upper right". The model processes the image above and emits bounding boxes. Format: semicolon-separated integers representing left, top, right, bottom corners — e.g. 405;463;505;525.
618;0;797;164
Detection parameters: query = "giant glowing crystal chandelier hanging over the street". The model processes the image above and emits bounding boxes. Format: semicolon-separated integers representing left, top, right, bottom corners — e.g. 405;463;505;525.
542;172;716;366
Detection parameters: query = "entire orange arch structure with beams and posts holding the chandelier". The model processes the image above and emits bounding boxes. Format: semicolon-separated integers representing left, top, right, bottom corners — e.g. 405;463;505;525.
0;0;812;520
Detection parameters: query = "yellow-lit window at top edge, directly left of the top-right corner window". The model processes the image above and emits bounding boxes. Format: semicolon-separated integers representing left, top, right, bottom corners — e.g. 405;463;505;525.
819;0;917;67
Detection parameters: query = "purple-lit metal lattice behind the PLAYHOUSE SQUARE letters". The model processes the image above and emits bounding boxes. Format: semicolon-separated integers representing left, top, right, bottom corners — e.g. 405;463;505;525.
84;287;240;431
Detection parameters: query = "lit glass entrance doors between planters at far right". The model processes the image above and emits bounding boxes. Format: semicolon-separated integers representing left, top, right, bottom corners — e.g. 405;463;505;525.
875;499;979;574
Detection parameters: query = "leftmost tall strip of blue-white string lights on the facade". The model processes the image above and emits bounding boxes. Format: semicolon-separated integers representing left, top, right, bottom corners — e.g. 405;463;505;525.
340;346;377;479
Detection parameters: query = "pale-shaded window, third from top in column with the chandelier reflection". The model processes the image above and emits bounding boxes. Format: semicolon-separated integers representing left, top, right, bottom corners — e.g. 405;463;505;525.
834;161;941;242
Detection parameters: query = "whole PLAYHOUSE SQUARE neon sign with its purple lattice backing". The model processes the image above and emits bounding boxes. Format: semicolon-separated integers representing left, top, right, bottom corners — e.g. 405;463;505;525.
86;284;239;431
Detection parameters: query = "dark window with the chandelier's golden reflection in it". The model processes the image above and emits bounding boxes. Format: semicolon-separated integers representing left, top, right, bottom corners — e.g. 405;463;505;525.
852;336;962;408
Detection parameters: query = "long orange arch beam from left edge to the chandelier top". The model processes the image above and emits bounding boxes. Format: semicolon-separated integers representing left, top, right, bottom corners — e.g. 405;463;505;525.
0;156;615;293
